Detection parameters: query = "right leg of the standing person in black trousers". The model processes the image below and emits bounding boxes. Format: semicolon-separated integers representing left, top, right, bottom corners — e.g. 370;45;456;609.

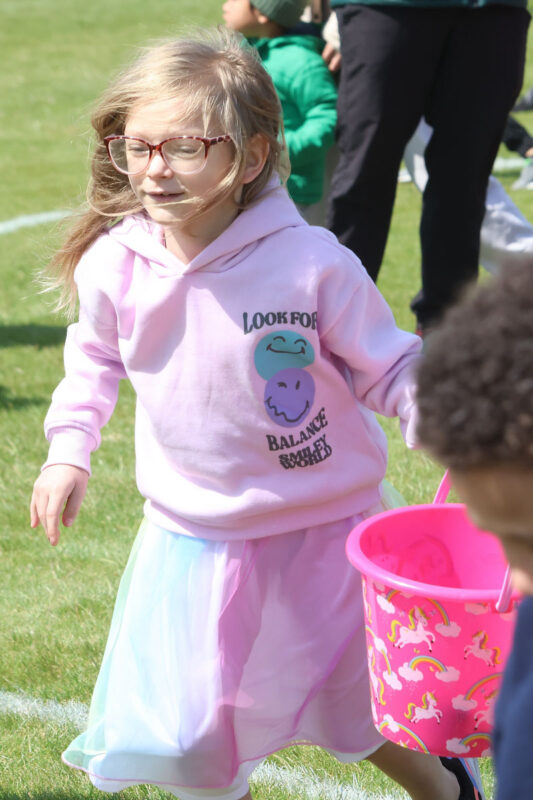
411;5;529;329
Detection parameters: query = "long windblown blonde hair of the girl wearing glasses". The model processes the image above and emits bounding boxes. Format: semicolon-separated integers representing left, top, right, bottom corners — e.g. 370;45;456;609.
48;29;284;313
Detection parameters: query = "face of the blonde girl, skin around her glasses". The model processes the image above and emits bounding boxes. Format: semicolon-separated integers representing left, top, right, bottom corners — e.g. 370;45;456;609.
124;100;240;246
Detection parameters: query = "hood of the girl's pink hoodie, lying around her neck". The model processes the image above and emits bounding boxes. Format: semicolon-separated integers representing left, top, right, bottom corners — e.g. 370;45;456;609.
108;175;307;277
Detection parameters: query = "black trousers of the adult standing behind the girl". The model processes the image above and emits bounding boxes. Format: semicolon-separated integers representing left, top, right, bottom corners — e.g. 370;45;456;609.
328;5;529;325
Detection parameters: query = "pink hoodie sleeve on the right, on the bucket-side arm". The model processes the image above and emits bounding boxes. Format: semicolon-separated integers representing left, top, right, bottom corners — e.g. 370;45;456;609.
318;248;422;447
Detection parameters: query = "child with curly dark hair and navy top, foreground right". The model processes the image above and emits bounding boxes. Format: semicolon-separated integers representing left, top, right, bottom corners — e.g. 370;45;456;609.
417;262;533;800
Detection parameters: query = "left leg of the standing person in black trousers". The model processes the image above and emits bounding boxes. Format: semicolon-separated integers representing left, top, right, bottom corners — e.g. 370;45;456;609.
328;5;446;280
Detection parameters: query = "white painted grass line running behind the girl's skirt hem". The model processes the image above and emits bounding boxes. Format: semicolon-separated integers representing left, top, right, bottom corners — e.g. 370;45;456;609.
0;690;407;800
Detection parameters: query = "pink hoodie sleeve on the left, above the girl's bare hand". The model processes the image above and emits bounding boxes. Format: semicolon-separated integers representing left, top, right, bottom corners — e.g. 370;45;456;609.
44;244;126;472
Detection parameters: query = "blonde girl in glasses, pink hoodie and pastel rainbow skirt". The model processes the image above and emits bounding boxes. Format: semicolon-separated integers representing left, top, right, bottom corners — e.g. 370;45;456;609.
31;26;475;800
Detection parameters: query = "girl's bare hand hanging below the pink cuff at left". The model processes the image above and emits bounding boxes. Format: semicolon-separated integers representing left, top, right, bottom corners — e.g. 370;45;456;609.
30;464;89;545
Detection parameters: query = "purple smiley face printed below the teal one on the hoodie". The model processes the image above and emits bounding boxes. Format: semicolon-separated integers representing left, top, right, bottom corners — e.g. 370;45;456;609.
265;367;315;428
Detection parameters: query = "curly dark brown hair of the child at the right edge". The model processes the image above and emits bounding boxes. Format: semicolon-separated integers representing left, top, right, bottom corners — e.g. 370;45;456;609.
417;259;533;469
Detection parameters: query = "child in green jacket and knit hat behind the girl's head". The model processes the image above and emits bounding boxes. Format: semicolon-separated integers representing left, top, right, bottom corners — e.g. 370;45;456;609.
223;0;337;225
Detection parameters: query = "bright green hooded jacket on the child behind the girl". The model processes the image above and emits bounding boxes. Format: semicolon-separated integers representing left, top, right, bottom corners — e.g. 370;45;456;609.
250;34;337;205
